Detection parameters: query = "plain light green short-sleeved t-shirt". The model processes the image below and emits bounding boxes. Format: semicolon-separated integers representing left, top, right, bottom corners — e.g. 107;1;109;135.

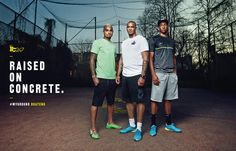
91;39;116;79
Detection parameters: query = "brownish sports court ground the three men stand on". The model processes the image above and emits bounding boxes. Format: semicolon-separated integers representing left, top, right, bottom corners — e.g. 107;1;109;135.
0;88;236;151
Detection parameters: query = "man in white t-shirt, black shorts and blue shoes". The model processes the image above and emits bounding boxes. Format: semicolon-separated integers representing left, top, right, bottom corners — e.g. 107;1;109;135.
116;21;149;141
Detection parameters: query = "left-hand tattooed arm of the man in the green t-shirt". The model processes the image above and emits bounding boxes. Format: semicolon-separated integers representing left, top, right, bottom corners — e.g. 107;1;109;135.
89;52;99;86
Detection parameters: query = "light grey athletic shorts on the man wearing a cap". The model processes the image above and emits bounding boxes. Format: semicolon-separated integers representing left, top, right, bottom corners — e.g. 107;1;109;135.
151;72;178;102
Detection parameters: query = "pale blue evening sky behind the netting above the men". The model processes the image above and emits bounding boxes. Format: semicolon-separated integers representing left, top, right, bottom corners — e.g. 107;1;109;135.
0;0;192;51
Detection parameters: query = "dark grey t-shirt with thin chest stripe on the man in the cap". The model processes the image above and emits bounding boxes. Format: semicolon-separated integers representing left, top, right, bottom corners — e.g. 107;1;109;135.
149;35;175;72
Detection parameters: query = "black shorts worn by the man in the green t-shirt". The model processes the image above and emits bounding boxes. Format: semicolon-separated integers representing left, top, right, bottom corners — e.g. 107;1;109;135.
92;78;117;106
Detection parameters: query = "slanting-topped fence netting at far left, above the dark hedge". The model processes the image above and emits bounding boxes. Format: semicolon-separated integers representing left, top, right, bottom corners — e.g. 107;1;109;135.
0;2;60;47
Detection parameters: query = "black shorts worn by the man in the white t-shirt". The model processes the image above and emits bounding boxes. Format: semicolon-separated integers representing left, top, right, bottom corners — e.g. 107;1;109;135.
121;75;144;103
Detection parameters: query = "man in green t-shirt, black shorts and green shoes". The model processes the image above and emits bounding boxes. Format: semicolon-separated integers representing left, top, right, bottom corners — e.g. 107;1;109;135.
89;24;121;139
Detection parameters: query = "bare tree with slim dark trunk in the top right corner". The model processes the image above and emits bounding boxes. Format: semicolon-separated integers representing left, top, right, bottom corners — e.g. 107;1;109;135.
194;0;235;65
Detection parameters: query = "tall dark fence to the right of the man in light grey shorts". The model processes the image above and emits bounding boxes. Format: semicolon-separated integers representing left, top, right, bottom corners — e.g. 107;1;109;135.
178;21;236;88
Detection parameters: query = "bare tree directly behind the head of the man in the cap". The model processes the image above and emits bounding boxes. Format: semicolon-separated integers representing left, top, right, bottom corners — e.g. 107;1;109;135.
139;0;184;38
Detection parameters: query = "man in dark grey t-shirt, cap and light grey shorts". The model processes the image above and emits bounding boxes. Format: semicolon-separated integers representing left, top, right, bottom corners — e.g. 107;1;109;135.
149;19;181;136
